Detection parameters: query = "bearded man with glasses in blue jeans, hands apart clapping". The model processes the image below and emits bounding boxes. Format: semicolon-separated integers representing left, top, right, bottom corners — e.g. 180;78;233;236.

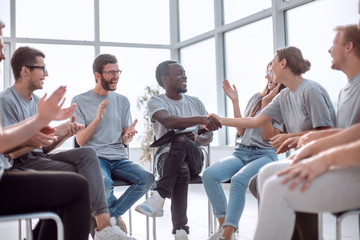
72;54;155;235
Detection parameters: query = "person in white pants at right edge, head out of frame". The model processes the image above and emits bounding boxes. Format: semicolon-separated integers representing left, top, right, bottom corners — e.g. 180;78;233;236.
254;124;360;240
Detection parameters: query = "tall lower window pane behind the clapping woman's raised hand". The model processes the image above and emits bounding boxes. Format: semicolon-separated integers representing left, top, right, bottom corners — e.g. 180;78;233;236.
225;18;274;145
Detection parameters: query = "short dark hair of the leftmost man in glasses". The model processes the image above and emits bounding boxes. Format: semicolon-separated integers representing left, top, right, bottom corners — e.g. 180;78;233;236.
11;46;45;81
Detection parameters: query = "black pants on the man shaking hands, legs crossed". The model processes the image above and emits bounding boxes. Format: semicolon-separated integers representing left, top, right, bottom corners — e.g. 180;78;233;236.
154;135;204;233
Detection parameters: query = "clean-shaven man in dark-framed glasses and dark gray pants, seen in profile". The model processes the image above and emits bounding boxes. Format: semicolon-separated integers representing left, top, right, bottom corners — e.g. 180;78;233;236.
0;47;133;240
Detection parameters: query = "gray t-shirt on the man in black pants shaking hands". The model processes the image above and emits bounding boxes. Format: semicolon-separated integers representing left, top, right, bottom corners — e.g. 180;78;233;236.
147;94;208;156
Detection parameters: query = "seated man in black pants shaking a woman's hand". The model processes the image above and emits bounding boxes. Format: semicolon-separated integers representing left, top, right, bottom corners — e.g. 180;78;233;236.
135;61;221;239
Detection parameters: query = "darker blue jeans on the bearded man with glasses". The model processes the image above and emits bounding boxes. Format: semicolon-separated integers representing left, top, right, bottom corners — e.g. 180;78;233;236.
99;157;155;218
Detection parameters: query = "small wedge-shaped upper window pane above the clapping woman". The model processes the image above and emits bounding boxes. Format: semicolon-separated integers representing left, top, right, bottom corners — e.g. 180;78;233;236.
224;0;271;24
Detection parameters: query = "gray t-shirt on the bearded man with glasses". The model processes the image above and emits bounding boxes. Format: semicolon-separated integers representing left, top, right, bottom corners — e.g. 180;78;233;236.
72;90;132;160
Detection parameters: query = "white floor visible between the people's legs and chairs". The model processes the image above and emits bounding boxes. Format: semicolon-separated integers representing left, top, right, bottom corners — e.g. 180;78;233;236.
0;185;360;240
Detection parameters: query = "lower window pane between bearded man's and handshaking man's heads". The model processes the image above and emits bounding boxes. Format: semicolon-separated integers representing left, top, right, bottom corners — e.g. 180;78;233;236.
101;47;170;147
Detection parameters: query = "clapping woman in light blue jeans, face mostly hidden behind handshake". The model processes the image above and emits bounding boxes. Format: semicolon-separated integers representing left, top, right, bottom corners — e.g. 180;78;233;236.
203;63;284;240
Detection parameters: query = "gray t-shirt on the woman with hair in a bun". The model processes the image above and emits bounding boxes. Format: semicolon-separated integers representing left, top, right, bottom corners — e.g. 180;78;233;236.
261;79;336;133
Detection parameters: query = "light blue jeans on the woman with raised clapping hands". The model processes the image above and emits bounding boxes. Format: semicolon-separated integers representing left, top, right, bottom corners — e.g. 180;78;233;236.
203;144;277;229
